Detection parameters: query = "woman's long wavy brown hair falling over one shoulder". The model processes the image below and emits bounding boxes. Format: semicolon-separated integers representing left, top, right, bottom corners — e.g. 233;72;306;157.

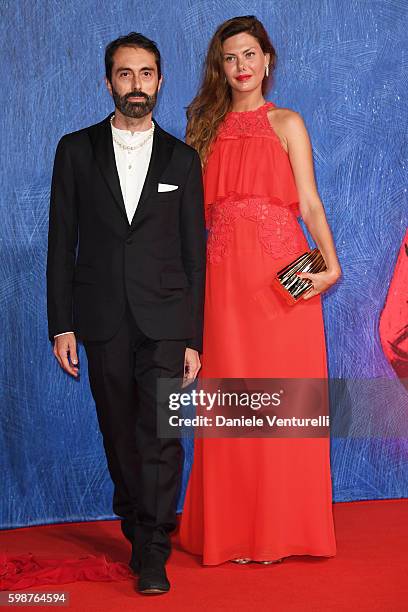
186;15;277;165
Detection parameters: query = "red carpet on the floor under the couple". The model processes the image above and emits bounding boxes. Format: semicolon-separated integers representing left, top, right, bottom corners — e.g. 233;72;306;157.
0;500;408;612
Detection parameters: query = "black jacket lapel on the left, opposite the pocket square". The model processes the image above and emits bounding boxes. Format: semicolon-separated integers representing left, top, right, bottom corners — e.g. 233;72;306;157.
89;115;128;221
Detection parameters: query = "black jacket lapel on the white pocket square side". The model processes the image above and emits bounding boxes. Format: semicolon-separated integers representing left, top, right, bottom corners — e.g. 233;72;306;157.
131;121;174;227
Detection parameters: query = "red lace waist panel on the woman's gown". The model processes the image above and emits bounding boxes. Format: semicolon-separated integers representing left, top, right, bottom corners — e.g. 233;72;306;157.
207;194;304;264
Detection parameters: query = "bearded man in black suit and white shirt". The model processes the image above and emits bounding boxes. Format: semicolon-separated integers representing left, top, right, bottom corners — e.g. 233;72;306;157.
47;33;205;593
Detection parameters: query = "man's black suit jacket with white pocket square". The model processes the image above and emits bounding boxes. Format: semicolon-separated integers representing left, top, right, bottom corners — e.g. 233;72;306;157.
47;116;205;351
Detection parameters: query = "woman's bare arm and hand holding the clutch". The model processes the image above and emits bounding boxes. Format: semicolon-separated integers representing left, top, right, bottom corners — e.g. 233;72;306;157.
281;110;341;299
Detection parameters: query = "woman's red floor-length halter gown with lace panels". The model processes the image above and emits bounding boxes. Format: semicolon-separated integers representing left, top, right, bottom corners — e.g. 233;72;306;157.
180;102;336;565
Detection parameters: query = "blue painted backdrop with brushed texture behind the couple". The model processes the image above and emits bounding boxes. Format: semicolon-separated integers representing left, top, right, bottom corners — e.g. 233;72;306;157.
0;0;408;527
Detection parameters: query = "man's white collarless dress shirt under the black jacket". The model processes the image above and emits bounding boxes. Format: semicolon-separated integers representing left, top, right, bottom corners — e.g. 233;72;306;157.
54;117;154;338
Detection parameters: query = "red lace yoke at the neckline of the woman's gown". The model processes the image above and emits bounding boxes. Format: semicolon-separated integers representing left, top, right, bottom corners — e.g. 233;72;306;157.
217;102;277;140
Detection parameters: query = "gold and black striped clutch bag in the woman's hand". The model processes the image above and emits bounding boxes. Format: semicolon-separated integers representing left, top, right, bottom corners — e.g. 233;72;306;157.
272;249;327;306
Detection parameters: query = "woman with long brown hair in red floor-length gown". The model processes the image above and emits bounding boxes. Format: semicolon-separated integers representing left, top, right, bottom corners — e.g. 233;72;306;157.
180;17;340;565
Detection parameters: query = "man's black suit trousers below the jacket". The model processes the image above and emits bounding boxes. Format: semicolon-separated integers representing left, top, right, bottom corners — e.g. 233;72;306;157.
84;306;186;560
